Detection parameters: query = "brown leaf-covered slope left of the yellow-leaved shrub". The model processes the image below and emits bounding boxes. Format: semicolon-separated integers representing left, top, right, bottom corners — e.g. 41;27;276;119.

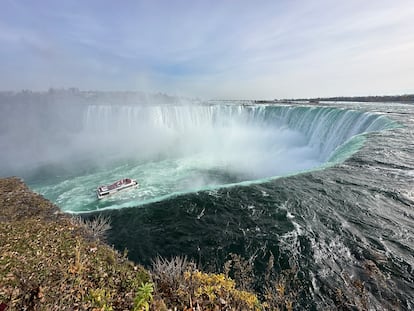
0;178;149;311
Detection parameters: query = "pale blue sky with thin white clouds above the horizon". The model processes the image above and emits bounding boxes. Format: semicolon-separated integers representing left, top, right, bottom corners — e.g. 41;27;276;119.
0;0;414;99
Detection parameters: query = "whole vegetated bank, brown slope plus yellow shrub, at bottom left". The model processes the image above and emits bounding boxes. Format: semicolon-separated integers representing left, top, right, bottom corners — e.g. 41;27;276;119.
0;178;266;311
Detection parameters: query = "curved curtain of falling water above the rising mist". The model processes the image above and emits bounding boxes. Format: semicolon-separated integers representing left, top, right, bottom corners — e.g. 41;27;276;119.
84;104;391;162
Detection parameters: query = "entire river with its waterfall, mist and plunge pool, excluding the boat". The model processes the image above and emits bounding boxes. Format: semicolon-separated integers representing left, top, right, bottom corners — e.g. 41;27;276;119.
0;97;414;310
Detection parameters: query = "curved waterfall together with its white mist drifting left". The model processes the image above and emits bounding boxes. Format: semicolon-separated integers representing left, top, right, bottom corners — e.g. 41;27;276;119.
0;102;393;177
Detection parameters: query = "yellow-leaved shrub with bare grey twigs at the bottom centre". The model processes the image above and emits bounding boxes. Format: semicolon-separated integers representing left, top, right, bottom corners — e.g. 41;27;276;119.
152;257;261;310
